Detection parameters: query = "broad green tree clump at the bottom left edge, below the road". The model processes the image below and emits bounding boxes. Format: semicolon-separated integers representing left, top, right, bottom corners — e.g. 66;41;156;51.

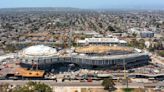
13;81;52;92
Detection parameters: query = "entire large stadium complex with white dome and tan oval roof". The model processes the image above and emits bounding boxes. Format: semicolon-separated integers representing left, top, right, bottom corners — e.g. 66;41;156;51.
18;45;150;70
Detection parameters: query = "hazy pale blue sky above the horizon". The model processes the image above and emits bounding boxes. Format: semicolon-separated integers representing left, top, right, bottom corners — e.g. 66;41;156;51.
0;0;164;9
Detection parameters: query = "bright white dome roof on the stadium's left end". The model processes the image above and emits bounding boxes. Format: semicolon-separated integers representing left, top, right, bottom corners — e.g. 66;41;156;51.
20;45;57;57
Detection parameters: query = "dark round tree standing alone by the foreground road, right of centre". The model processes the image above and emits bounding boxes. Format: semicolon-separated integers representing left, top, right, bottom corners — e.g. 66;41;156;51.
102;78;116;92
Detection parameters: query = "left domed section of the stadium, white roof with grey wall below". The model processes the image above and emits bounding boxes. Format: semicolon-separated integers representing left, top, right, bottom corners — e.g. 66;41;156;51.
18;45;58;71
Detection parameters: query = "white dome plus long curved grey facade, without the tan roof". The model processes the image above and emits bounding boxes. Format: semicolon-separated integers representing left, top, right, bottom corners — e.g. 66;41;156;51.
19;45;150;69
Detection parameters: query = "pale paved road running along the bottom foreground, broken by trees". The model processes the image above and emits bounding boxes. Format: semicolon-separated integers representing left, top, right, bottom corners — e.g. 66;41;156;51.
0;80;164;88
